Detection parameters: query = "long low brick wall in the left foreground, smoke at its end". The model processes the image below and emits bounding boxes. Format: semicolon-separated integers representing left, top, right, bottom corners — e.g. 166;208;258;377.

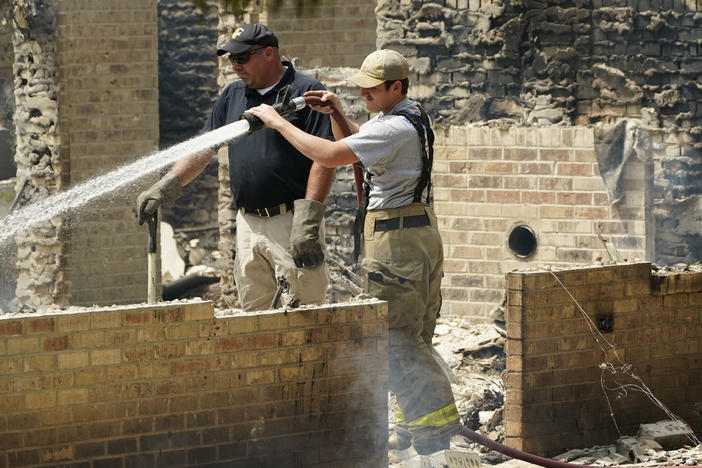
0;301;387;467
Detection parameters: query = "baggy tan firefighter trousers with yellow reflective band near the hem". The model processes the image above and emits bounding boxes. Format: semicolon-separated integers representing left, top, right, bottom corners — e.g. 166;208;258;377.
362;203;462;439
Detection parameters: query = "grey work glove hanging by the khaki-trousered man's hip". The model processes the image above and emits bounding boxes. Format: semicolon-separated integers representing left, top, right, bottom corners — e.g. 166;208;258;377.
290;199;326;268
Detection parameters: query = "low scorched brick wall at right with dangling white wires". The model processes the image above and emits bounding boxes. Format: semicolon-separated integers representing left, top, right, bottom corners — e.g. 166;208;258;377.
505;263;702;456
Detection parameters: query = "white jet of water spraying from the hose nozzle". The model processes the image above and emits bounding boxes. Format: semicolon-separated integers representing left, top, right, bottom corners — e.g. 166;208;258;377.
0;120;249;246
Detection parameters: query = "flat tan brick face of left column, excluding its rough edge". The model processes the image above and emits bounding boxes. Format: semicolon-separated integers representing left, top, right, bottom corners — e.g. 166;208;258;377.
57;0;159;305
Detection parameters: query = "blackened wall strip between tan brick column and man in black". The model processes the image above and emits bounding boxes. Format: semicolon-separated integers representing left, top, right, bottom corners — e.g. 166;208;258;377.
158;0;218;241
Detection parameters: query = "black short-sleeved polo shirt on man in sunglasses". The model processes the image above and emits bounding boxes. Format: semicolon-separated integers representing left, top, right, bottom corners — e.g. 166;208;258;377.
202;62;333;208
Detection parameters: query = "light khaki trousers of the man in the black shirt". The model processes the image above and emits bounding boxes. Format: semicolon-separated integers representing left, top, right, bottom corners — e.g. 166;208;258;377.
234;211;328;311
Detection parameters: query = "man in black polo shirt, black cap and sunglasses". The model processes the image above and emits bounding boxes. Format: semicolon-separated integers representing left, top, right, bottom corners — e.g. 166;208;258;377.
137;23;334;310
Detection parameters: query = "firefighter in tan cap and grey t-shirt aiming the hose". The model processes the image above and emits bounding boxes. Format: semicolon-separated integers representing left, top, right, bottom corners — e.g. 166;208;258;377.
250;50;462;454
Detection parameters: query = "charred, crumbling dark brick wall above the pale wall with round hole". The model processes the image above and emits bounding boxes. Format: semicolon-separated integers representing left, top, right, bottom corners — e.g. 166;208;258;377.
376;0;702;263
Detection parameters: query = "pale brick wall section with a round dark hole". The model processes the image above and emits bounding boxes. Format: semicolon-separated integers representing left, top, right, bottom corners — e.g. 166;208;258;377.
434;126;652;320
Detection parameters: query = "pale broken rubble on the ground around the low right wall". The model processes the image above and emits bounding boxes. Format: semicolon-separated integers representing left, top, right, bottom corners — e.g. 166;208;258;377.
388;318;702;468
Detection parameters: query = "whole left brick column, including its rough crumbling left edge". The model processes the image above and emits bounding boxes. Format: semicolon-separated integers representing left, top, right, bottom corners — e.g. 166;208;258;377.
4;0;158;308
